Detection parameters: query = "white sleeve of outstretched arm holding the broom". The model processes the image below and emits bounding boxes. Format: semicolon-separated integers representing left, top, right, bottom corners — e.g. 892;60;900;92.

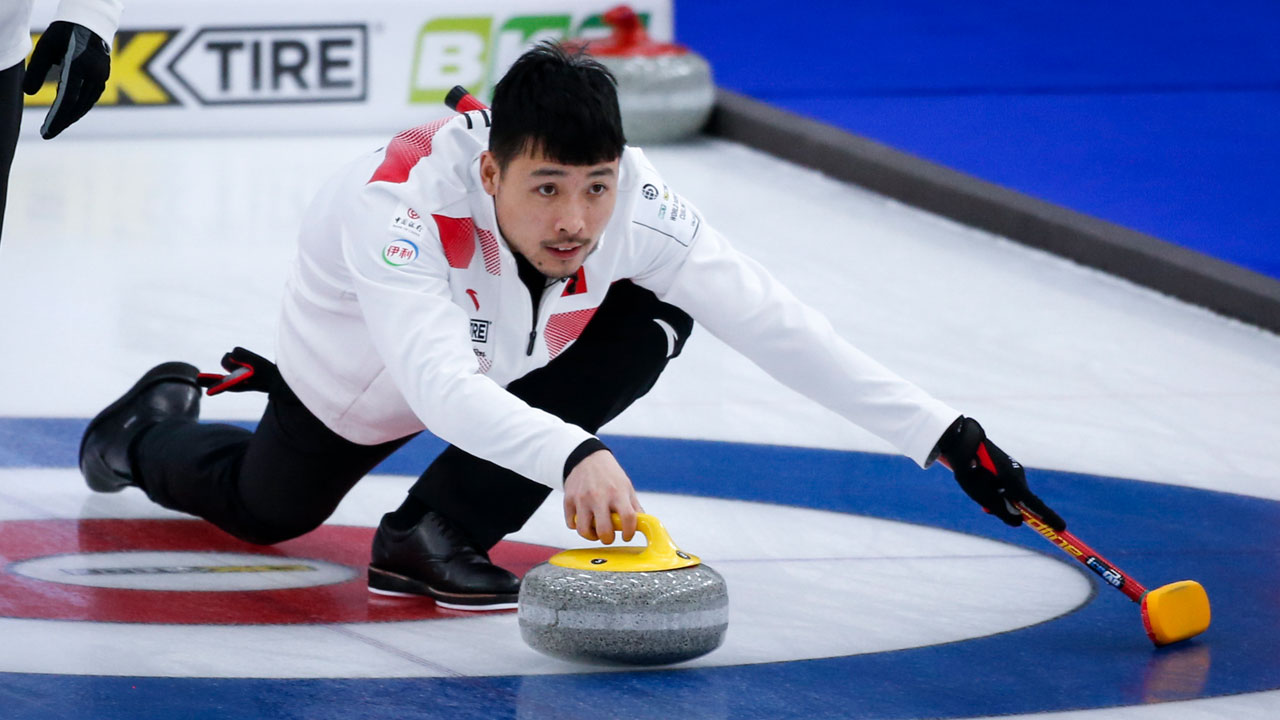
657;223;960;466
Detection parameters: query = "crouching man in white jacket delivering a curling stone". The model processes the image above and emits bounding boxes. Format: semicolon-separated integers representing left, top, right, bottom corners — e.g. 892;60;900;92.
81;45;1064;609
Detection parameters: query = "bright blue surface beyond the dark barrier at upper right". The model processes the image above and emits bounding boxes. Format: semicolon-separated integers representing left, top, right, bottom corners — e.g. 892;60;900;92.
676;0;1280;278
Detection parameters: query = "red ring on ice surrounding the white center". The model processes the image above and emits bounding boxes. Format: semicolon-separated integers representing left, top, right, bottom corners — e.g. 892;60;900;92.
0;519;558;625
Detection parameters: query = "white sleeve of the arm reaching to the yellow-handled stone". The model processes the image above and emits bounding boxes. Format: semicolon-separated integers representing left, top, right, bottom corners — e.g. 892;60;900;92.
342;183;593;488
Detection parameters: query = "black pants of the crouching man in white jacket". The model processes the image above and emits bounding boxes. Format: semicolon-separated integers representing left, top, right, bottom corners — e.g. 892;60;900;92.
132;282;692;548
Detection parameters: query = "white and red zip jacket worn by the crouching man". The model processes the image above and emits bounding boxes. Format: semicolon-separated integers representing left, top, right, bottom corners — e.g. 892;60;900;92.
276;111;959;488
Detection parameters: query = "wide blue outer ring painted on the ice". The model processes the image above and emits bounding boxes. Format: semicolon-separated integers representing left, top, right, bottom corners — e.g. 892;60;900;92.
0;419;1280;720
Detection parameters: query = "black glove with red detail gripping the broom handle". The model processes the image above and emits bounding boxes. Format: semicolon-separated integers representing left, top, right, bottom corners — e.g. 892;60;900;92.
938;418;1066;530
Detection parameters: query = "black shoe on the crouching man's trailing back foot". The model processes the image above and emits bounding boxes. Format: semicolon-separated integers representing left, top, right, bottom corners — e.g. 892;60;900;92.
79;363;200;492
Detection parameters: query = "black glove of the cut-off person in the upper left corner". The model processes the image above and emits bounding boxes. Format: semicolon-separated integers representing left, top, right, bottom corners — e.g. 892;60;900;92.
22;20;111;140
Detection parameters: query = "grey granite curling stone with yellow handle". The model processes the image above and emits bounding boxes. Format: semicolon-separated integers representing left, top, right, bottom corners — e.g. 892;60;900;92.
518;514;728;665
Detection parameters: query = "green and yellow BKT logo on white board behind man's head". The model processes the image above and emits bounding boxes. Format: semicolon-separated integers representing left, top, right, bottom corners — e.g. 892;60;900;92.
408;13;649;105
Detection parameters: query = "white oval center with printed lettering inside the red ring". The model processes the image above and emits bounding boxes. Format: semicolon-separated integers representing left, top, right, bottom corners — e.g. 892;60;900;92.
9;551;356;592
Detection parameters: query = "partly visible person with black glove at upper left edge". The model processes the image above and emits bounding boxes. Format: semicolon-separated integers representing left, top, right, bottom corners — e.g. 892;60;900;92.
0;0;120;237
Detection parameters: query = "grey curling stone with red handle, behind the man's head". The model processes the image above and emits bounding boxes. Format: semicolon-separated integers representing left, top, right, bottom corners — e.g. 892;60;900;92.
567;5;716;145
